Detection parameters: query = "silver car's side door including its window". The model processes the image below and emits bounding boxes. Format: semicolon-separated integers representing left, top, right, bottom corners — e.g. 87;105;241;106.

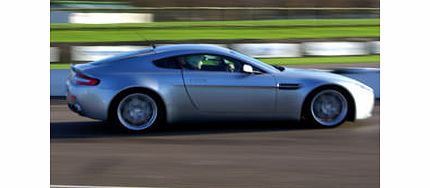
179;54;276;113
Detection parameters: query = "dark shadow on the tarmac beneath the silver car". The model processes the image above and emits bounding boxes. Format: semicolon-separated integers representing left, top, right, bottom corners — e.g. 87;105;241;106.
50;121;320;139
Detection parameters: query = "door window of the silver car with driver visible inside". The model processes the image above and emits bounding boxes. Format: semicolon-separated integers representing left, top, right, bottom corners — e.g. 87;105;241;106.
178;54;256;72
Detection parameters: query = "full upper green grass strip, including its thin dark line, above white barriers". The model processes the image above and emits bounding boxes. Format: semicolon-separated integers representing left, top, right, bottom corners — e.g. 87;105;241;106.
51;19;379;43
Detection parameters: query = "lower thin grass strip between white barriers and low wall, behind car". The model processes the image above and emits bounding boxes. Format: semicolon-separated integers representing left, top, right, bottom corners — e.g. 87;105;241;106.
51;55;379;69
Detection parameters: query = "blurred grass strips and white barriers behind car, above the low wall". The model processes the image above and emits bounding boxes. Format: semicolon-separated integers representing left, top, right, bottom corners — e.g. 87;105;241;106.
50;0;379;69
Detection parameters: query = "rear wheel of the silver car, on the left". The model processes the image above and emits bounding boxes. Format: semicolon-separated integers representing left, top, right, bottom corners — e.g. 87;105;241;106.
111;92;163;132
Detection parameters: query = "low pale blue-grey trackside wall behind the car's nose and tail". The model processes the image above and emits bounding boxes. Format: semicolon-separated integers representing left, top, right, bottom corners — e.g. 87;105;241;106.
50;68;380;98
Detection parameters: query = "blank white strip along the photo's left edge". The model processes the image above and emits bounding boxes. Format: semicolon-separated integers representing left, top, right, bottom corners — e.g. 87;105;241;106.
0;0;50;188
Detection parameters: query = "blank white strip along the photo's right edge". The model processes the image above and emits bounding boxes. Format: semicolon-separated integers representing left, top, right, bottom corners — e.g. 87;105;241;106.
380;0;430;188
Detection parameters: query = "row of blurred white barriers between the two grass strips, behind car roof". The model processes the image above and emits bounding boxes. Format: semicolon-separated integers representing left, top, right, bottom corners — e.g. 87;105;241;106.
51;41;379;63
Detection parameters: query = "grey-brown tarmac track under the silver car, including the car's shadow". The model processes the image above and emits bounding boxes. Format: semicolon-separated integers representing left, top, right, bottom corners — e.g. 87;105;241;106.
51;100;380;188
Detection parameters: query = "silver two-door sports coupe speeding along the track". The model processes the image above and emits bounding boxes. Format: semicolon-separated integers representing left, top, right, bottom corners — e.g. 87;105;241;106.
66;45;374;131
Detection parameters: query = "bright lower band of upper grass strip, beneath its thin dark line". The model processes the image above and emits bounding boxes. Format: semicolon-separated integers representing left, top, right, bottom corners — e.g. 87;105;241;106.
51;27;379;42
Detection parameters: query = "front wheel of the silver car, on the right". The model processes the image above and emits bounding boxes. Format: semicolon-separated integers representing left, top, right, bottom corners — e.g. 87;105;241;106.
304;88;351;128
